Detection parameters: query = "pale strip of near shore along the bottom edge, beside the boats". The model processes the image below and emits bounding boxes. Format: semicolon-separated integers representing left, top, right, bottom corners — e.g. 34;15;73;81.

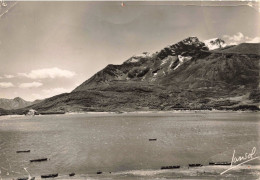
0;164;260;180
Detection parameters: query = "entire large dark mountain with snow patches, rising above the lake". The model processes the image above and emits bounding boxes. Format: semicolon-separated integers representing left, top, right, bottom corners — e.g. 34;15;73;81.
4;37;260;113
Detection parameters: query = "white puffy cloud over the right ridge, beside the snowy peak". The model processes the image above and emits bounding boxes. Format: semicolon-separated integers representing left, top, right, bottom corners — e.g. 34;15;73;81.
223;32;260;45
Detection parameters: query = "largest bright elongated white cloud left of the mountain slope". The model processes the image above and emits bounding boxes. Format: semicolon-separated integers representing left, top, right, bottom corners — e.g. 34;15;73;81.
18;67;75;79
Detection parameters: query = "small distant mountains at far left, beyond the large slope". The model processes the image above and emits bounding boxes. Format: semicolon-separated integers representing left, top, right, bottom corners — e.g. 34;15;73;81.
0;97;39;110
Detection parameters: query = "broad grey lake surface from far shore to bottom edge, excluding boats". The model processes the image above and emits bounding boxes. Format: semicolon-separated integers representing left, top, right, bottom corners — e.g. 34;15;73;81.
0;112;260;180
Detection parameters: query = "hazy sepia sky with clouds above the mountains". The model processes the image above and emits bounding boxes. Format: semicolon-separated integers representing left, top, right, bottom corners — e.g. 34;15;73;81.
0;1;260;101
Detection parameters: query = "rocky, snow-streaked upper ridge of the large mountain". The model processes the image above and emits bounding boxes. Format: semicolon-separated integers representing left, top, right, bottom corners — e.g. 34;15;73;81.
73;37;209;92
